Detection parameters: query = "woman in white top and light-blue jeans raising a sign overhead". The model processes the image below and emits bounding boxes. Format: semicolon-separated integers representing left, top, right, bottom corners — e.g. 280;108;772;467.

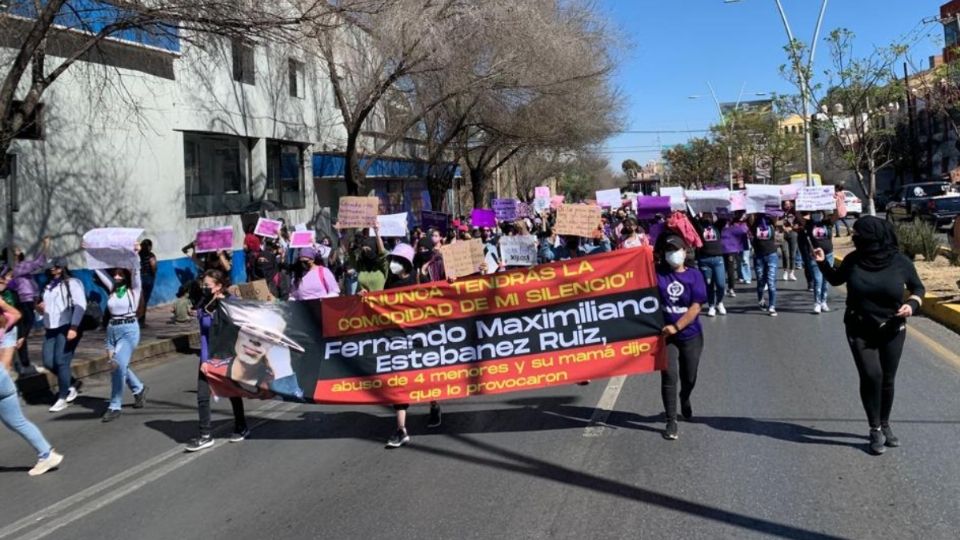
96;251;147;422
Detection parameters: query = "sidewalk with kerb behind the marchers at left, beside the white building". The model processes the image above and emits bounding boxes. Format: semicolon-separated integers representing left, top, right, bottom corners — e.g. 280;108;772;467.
14;304;200;395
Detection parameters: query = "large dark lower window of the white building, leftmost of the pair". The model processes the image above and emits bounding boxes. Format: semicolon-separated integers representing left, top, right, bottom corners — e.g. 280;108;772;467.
183;132;253;217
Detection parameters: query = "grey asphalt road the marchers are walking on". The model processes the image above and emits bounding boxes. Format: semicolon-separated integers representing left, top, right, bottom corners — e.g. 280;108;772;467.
0;278;960;540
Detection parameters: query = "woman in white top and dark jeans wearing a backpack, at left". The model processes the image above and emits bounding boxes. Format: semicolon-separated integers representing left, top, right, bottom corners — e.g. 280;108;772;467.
37;258;87;412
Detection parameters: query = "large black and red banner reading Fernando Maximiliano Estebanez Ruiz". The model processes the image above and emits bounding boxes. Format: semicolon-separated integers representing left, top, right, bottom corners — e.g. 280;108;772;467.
203;248;666;404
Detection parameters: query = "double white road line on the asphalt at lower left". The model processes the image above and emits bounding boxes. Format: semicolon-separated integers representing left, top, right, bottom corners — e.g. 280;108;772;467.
0;401;297;539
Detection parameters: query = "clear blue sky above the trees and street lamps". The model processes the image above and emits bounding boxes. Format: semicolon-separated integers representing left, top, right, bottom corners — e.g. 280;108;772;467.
598;0;945;171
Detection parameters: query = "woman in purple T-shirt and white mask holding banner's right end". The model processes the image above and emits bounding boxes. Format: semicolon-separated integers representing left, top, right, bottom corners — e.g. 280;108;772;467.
655;233;707;440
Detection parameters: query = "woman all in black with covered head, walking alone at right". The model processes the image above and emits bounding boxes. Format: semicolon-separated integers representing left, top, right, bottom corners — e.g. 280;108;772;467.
813;216;924;455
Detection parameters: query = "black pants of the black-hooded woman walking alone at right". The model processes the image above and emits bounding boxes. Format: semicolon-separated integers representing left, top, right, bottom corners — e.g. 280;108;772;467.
847;323;907;428
